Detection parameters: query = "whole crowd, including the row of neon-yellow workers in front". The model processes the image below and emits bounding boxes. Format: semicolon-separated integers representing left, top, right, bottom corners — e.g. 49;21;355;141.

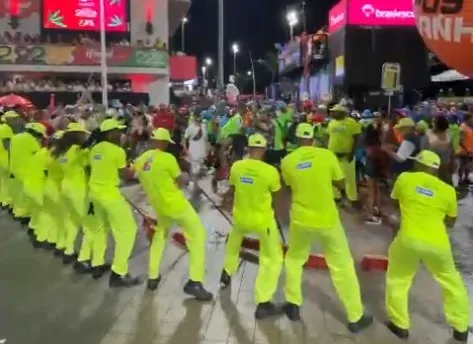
0;96;473;342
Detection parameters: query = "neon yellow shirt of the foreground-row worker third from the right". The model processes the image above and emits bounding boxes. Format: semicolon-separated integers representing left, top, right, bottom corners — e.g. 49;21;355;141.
229;159;281;231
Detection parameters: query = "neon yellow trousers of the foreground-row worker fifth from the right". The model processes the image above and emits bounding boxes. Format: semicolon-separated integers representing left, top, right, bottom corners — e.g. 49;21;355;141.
92;196;138;276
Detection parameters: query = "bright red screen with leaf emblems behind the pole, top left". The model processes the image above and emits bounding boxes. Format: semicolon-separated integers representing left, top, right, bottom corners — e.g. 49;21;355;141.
43;0;128;32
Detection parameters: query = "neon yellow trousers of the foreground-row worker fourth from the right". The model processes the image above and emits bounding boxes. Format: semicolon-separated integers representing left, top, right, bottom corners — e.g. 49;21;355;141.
148;203;207;282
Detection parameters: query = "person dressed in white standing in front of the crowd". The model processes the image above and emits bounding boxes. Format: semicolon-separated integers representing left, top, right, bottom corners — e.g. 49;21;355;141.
184;114;208;189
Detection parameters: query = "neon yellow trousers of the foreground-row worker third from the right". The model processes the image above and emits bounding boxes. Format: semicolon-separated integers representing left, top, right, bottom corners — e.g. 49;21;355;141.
224;218;284;304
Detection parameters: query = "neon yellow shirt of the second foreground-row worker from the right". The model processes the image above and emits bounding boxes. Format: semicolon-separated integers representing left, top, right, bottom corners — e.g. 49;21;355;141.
281;146;344;229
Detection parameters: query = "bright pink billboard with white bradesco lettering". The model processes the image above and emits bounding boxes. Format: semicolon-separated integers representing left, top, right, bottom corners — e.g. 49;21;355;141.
328;0;416;33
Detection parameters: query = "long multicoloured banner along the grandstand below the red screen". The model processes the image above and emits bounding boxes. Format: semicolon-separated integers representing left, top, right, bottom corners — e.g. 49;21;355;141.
0;44;169;69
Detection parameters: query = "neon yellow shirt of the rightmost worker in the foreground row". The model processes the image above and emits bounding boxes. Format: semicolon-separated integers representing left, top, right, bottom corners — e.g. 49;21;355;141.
391;172;458;246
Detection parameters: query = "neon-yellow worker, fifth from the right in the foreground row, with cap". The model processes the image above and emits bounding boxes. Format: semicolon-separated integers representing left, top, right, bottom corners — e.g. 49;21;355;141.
89;118;141;287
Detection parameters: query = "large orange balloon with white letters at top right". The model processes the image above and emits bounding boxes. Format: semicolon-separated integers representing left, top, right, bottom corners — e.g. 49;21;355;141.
414;0;473;76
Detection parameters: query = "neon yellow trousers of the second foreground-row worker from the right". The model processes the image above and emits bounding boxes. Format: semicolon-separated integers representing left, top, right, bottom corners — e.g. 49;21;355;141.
285;221;364;322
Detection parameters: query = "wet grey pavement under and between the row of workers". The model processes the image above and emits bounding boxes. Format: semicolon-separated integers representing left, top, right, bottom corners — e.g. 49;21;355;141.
0;181;473;344
